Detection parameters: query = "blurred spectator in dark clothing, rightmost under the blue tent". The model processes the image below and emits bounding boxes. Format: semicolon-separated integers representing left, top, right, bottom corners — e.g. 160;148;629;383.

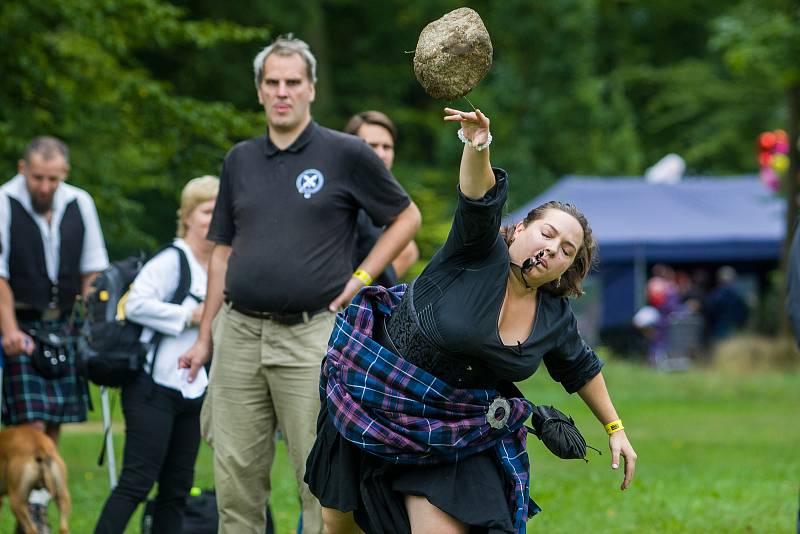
704;265;749;342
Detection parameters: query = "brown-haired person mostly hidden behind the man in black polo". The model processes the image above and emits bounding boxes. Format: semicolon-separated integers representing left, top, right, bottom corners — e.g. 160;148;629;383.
344;111;419;287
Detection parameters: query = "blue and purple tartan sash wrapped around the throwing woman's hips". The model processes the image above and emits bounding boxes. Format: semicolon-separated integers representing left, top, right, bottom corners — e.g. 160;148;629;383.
320;285;540;533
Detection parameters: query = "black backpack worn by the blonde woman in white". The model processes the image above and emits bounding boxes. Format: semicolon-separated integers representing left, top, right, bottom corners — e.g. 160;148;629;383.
80;244;192;387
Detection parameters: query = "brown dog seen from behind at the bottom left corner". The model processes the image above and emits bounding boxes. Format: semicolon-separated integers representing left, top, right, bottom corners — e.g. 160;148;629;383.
0;425;72;534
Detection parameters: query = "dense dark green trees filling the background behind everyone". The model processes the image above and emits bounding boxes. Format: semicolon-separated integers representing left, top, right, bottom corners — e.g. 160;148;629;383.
0;0;800;276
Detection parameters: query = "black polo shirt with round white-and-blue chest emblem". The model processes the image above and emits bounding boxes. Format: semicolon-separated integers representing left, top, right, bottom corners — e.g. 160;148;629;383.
208;121;411;313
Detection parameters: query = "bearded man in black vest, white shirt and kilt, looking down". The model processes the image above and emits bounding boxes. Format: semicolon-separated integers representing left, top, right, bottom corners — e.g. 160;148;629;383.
0;136;108;531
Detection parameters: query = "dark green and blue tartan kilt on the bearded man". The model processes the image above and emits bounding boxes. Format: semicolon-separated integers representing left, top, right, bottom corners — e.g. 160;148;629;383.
3;354;86;425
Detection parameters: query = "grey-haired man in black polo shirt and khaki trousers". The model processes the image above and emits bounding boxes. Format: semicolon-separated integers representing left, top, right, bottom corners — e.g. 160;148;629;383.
181;37;420;534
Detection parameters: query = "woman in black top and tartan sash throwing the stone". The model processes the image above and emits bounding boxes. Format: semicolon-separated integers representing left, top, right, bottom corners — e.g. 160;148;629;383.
306;108;636;533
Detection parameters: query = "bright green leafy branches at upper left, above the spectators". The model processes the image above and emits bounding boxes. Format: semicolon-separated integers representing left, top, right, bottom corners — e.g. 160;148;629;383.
0;0;268;257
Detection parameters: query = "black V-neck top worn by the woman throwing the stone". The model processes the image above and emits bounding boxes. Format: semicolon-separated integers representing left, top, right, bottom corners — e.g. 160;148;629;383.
404;169;602;393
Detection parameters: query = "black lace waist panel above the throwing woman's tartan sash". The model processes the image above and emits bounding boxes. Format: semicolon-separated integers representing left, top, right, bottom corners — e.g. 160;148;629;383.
378;291;497;388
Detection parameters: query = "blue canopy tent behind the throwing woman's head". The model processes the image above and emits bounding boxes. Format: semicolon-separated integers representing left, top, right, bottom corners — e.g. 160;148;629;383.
504;176;786;328
